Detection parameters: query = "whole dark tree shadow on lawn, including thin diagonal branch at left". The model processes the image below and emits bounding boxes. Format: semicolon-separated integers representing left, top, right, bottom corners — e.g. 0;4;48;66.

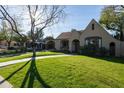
0;54;50;88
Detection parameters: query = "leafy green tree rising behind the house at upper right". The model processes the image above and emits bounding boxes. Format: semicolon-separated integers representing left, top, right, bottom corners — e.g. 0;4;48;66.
99;6;124;41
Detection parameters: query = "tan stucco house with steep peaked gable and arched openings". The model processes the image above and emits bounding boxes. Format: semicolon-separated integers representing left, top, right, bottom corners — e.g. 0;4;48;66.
50;19;124;56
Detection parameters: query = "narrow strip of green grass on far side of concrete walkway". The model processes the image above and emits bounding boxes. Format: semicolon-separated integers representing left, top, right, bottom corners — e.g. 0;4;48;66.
0;51;63;62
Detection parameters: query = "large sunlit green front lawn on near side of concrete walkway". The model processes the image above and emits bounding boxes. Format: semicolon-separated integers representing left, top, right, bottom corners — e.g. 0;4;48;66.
0;56;124;88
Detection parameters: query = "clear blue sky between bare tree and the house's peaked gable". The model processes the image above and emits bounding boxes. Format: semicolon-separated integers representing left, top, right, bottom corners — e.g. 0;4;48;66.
44;5;104;38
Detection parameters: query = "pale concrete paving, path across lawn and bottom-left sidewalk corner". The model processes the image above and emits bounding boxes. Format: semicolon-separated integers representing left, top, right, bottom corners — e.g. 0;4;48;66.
0;54;72;88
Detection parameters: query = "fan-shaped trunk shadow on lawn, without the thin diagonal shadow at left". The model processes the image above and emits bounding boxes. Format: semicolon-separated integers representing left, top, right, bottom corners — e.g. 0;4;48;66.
21;53;50;88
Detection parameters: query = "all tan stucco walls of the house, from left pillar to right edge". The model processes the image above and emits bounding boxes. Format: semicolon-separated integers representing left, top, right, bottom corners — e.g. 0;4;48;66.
55;19;124;56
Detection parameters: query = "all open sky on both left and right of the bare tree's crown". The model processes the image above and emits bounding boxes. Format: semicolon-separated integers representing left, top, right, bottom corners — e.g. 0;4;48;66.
0;5;104;38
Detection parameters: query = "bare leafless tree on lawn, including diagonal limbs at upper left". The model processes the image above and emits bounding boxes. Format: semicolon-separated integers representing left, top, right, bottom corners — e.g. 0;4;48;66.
0;5;64;53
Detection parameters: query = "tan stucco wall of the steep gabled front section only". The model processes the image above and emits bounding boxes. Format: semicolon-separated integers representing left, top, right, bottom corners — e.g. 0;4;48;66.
80;20;120;56
